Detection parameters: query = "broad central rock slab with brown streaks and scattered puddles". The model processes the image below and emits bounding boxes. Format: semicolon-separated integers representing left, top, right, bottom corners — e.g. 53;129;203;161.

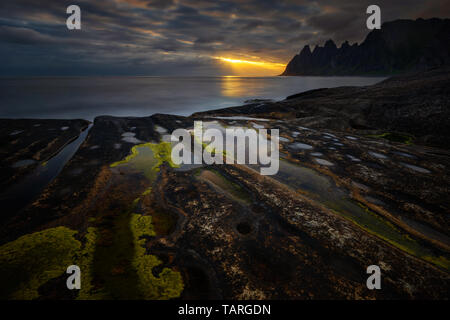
1;115;450;299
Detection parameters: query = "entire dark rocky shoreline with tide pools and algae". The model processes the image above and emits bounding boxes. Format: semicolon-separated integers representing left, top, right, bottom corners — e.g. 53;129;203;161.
0;69;450;299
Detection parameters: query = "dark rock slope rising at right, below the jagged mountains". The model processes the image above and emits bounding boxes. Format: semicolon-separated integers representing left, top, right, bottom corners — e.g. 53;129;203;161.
199;67;450;148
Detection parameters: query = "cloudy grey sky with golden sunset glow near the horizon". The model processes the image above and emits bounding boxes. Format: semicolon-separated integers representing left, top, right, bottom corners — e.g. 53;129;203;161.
0;0;450;76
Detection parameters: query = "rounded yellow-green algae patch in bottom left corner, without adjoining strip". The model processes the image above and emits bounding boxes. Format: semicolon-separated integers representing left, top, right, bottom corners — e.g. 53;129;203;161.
0;227;81;300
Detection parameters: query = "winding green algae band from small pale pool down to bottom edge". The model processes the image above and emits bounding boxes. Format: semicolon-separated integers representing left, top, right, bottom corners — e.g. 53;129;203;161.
94;142;184;299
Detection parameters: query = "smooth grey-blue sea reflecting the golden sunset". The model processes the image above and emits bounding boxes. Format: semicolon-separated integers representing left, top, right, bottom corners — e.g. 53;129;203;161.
0;77;384;120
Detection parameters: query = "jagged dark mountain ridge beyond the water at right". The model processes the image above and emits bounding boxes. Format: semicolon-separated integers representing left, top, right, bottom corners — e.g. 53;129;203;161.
282;18;450;76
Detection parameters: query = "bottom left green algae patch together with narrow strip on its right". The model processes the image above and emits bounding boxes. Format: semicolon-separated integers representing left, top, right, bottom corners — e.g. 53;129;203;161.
0;227;105;300
